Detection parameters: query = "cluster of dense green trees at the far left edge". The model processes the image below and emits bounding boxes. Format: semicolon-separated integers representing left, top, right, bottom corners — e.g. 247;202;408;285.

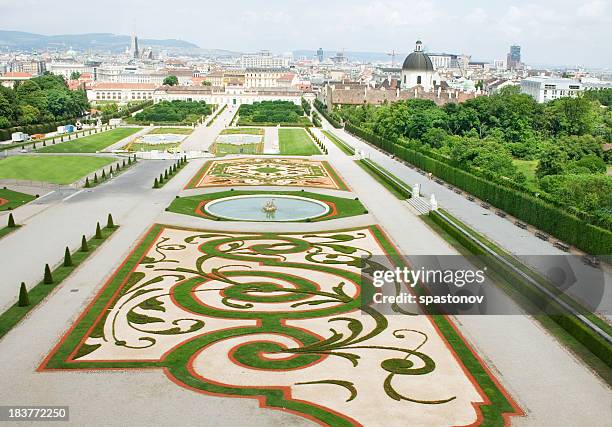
0;73;89;128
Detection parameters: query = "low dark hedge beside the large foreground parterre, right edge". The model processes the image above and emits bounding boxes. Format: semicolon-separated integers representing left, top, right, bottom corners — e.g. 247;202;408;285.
429;211;612;366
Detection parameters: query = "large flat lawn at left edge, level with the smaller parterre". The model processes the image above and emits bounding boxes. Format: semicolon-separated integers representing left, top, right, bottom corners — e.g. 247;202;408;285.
0;156;117;184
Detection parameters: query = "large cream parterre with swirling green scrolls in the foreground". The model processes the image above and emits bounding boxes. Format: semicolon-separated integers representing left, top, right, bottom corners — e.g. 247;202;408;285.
40;225;520;426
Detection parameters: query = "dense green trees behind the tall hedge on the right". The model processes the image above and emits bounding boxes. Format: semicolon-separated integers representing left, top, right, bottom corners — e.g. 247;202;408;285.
335;87;612;221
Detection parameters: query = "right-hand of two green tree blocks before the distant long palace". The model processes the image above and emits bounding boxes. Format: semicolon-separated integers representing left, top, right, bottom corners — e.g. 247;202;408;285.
238;101;311;126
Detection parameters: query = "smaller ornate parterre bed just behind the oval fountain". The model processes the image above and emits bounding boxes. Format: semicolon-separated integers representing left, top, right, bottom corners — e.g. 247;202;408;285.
188;158;346;190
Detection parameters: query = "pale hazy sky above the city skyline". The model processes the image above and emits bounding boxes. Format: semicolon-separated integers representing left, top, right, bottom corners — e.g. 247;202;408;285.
0;0;612;68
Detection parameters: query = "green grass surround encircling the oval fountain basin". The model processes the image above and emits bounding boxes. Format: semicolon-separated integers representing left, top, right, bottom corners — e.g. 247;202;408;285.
168;191;367;222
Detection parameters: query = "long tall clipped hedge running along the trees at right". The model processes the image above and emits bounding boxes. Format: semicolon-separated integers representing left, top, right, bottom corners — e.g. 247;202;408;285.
345;123;612;256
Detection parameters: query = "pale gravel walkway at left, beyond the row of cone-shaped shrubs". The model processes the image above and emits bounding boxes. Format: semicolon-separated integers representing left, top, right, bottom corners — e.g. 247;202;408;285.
0;161;178;310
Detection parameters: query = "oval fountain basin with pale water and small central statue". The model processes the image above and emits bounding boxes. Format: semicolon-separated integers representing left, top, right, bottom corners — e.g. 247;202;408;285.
204;194;330;222
